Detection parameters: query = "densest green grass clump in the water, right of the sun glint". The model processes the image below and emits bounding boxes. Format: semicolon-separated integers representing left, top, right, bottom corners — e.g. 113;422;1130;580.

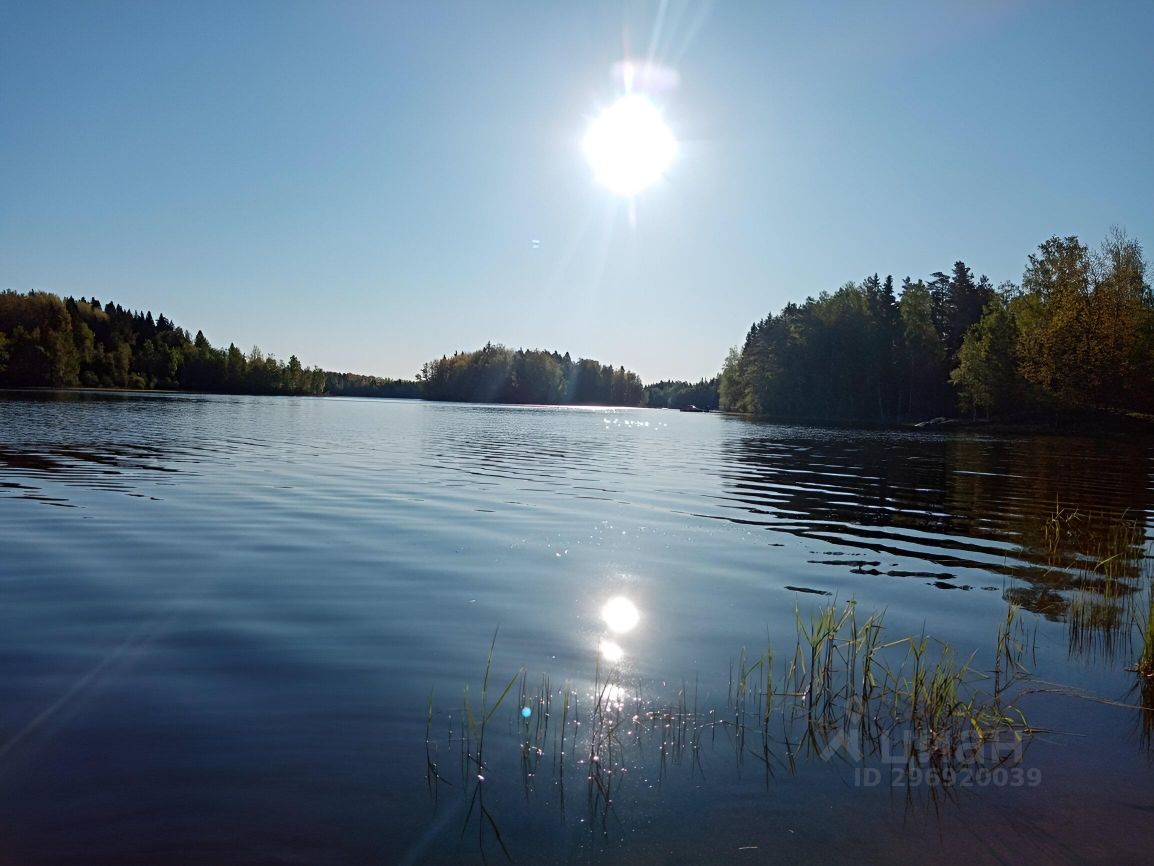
710;600;1033;768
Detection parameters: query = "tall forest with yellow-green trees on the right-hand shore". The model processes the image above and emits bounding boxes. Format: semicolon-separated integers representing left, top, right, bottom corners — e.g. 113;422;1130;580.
719;230;1154;421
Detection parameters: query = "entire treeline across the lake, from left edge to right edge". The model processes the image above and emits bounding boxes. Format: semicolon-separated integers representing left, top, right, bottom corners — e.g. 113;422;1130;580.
0;231;1154;423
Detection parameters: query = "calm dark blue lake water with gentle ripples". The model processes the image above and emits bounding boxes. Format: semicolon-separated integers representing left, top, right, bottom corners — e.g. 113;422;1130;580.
0;393;1154;865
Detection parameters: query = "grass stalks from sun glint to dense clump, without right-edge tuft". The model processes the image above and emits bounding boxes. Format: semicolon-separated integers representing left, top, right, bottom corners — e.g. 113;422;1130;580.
426;599;1033;857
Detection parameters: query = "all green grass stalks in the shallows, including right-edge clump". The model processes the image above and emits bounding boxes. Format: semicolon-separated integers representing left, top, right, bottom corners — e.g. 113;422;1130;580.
426;509;1154;857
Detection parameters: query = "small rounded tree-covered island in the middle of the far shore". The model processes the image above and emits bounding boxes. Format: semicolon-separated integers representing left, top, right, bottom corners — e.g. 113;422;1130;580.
418;343;643;406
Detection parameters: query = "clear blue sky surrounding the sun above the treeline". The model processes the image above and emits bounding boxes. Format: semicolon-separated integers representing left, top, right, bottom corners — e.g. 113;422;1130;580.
0;0;1154;381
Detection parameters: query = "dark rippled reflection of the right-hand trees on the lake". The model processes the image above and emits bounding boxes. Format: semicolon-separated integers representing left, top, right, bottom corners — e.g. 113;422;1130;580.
722;426;1152;632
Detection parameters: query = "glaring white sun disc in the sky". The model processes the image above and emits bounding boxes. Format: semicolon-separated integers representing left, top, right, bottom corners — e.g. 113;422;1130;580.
584;94;677;196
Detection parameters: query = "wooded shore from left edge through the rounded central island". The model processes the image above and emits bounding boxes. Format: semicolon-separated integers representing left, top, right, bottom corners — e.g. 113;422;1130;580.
0;291;644;405
